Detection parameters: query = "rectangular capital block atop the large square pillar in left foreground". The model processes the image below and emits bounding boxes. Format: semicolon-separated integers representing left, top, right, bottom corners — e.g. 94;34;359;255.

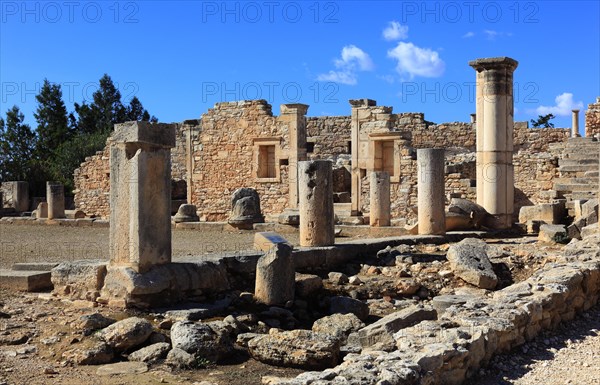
112;122;175;148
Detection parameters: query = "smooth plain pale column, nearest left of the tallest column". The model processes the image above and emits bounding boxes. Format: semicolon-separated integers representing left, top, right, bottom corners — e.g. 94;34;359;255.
417;148;446;235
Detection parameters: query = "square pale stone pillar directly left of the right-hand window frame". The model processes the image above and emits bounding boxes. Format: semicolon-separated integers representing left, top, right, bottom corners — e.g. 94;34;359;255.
349;99;377;215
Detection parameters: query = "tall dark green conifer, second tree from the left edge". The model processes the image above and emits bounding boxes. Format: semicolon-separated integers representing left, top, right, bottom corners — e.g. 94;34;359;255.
33;79;73;156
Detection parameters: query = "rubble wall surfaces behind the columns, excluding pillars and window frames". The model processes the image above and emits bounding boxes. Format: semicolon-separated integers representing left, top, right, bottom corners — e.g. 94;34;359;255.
75;100;576;223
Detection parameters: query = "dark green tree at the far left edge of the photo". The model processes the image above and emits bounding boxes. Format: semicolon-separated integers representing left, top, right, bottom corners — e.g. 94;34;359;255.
0;106;35;181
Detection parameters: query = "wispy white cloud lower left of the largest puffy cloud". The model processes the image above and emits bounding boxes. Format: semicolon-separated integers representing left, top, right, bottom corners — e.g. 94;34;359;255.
317;45;375;85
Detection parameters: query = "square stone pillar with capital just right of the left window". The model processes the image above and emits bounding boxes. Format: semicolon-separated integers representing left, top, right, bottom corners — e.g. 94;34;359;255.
279;103;308;209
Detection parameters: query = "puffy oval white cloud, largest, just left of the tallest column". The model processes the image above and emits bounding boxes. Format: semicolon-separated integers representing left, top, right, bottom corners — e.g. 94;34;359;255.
387;42;446;78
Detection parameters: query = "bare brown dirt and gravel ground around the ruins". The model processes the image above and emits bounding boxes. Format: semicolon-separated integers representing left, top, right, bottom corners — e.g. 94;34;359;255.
0;224;600;385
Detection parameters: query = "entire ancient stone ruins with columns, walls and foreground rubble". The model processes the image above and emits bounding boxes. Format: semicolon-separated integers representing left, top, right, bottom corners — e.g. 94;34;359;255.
0;57;600;385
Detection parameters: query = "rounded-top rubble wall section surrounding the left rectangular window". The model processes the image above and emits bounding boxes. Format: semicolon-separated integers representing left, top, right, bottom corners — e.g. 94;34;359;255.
191;100;289;221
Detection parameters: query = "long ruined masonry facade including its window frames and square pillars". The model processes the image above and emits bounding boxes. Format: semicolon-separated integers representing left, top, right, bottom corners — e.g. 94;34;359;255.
71;99;600;222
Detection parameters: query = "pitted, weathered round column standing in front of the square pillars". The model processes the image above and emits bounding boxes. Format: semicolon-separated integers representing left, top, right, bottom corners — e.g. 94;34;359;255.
298;160;335;246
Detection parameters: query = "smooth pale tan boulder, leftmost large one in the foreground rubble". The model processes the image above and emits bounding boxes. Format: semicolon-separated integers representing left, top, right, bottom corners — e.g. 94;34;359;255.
98;317;152;352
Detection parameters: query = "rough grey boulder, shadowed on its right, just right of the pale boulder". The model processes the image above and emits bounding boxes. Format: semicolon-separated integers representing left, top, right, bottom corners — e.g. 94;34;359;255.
171;321;233;362
